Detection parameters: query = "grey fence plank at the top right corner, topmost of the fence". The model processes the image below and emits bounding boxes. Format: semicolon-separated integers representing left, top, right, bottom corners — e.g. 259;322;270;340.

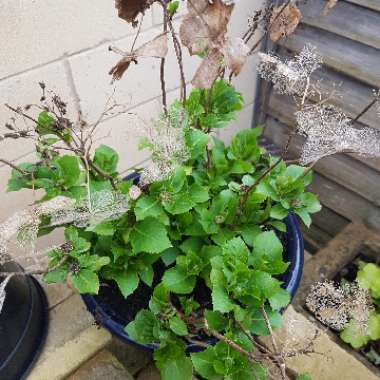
299;0;380;49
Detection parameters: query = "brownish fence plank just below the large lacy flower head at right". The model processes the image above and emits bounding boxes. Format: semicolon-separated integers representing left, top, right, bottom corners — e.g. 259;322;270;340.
265;114;380;206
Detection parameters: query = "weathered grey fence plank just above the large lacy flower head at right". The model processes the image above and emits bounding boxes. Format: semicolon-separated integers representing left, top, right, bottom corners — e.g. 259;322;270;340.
278;47;380;129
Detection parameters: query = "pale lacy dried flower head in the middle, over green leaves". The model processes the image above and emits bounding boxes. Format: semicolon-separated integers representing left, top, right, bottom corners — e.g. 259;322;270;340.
140;106;190;185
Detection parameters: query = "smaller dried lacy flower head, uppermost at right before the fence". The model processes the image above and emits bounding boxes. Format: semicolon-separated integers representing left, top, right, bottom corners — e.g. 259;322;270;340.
258;45;322;96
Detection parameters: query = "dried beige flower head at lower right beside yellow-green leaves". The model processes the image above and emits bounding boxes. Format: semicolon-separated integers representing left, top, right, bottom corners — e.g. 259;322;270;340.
306;281;373;331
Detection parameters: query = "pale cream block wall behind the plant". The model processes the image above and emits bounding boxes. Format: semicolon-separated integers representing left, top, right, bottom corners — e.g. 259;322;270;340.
0;0;263;229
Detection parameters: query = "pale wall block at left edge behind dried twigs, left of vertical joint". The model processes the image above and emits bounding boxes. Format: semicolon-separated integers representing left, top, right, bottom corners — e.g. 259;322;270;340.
0;60;76;166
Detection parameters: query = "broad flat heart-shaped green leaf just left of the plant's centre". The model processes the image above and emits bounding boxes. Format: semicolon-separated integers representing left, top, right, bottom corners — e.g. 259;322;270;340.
129;217;172;253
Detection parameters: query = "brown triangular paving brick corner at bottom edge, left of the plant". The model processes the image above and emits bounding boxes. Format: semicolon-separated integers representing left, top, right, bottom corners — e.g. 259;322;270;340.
67;350;133;380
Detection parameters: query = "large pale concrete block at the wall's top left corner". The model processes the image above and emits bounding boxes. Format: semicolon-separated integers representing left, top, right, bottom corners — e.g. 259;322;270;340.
0;0;152;78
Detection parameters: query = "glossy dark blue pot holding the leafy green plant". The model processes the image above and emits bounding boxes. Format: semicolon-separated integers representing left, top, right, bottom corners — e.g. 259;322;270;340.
82;214;304;352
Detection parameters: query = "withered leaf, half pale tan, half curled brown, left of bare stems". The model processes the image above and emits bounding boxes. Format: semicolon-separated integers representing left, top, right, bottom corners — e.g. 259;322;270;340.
109;33;168;80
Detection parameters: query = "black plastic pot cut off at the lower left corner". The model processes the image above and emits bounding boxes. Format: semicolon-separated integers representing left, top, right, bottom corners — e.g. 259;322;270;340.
0;263;48;380
